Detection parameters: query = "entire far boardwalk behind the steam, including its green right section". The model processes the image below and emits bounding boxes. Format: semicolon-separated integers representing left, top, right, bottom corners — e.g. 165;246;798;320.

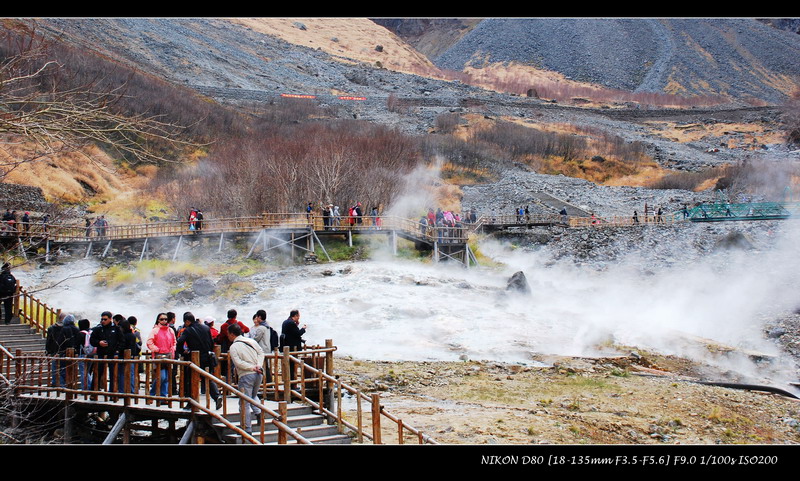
0;198;800;267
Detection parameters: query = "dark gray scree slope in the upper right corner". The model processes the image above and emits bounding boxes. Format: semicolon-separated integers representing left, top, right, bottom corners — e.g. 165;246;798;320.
434;18;800;102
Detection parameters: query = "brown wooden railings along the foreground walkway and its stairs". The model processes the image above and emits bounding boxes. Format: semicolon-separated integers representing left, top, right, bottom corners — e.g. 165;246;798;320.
0;341;437;444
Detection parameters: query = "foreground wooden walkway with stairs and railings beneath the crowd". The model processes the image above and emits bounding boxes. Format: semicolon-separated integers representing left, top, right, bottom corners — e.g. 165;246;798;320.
0;289;436;444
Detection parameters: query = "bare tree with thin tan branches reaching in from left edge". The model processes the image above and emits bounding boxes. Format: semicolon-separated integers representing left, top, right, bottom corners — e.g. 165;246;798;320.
0;23;191;180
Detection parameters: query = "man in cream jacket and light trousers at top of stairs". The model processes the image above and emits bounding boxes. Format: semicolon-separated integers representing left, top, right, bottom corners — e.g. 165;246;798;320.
228;324;264;433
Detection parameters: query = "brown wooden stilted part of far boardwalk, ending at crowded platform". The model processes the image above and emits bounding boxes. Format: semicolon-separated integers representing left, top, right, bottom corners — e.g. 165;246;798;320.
0;213;477;267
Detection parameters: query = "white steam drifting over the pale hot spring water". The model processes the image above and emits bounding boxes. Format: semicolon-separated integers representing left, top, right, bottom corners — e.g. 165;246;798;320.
17;221;800;388
